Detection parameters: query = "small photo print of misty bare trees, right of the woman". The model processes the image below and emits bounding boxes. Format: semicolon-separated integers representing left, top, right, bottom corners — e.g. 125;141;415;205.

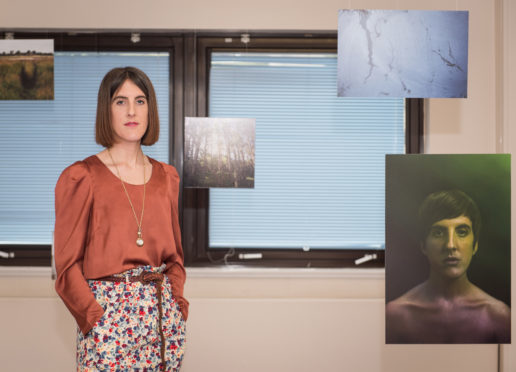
184;118;256;188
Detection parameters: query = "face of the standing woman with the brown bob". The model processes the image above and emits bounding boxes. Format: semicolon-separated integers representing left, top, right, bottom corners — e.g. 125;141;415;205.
111;79;149;144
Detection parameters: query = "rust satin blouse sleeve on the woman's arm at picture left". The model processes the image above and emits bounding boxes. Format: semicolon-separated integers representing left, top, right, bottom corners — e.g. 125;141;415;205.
54;162;104;335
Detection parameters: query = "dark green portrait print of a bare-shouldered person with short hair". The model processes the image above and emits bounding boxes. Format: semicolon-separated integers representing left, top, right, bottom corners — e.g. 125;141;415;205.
385;154;511;344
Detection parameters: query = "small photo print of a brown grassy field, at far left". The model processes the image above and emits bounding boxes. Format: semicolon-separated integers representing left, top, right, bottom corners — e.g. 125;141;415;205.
0;39;54;100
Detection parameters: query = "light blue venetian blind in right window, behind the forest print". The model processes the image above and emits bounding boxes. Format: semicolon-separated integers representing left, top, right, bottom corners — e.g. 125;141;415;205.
209;52;405;249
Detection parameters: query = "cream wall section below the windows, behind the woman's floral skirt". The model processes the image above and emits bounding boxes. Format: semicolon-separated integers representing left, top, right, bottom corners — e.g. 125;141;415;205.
0;268;497;372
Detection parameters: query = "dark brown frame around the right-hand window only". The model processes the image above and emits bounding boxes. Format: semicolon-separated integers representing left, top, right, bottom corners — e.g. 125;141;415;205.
182;33;424;267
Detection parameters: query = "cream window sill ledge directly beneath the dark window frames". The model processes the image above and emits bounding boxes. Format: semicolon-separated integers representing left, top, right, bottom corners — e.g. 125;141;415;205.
0;266;385;300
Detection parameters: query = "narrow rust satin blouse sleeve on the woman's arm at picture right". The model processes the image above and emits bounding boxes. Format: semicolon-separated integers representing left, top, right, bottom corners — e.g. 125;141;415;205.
165;165;189;320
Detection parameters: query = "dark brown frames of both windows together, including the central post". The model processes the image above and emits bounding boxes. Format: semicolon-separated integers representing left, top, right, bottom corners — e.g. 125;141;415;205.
0;30;424;267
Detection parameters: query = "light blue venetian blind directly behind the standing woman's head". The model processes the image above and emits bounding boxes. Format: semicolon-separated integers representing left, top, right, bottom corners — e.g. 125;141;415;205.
0;52;169;244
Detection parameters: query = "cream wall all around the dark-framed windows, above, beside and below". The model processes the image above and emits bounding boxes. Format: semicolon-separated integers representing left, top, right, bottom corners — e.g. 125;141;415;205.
0;0;516;372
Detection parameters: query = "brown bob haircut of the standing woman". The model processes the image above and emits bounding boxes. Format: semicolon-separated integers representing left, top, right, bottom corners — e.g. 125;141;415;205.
95;67;159;148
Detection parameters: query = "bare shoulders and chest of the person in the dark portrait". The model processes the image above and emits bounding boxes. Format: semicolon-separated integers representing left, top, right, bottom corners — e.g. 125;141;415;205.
386;283;511;344
